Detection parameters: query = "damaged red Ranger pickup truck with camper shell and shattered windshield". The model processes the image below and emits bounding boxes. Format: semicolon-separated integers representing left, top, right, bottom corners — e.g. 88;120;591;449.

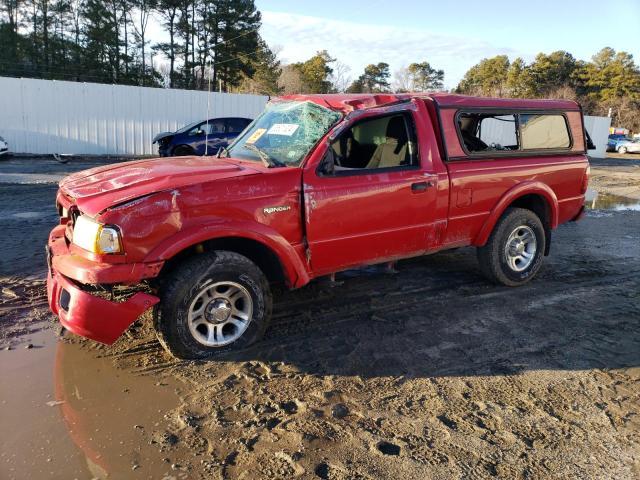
47;94;589;358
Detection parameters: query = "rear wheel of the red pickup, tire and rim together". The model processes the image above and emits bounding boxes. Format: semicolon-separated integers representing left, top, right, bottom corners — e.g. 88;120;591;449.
478;208;546;287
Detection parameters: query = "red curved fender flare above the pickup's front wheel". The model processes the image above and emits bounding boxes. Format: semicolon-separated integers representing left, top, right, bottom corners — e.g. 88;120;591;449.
145;220;310;287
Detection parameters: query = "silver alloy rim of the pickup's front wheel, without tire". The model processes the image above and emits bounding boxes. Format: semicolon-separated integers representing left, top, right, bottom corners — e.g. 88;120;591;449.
188;282;253;347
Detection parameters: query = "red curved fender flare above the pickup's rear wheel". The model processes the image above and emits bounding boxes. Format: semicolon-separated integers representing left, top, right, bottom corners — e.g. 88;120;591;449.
473;181;559;246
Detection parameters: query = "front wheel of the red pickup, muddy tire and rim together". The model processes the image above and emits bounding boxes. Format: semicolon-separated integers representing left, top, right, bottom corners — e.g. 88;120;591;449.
154;251;272;359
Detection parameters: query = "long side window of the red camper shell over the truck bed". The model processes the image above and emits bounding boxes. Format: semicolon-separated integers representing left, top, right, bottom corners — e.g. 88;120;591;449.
456;109;573;157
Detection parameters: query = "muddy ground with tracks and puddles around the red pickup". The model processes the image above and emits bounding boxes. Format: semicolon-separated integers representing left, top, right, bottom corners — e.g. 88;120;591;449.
0;157;640;479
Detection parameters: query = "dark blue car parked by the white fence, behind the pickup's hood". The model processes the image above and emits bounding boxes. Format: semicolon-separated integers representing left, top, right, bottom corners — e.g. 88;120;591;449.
153;117;252;157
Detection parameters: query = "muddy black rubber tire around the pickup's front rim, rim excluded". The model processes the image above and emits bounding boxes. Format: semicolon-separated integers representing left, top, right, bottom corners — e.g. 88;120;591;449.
153;250;272;359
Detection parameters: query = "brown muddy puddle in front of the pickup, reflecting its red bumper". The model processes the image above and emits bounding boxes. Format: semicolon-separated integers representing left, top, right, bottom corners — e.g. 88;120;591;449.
0;329;185;479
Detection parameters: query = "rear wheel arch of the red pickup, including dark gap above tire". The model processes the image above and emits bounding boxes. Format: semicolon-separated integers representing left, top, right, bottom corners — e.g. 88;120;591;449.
473;182;559;255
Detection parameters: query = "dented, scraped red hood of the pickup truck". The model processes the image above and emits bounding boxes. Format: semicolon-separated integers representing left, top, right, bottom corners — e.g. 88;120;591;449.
60;157;259;216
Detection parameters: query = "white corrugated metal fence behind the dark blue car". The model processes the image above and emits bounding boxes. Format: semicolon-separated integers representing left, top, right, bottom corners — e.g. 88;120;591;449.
0;77;267;155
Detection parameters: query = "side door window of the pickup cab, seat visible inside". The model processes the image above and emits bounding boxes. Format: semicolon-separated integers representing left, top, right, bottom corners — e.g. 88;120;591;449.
331;114;416;172
